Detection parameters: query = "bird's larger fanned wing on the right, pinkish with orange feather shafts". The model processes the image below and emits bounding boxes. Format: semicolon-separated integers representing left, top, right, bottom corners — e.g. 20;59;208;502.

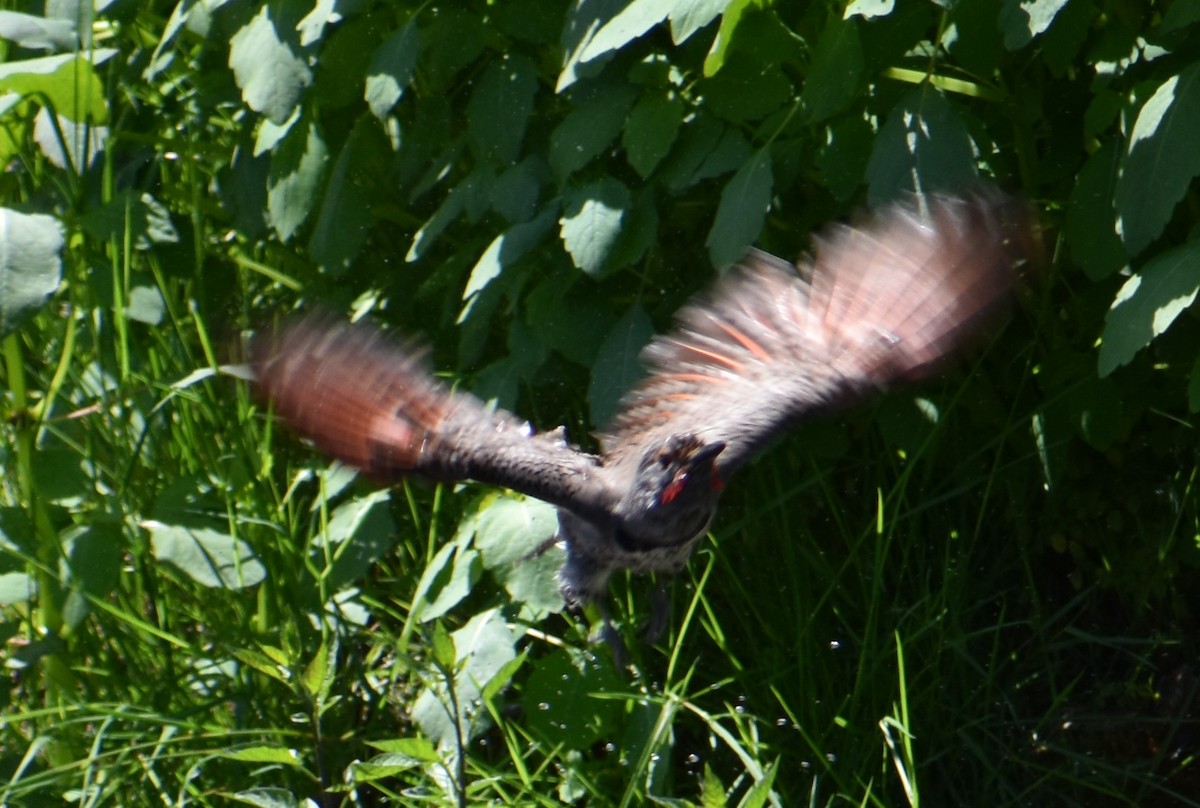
604;190;1034;474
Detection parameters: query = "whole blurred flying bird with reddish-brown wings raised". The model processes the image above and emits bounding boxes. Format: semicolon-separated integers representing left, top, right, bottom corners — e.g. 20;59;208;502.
253;191;1031;619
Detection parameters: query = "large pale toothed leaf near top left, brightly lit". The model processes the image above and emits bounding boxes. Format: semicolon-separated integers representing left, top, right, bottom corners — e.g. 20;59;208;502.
229;5;312;124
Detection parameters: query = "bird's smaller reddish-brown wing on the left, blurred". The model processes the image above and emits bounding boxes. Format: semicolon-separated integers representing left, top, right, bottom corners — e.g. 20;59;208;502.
251;316;614;514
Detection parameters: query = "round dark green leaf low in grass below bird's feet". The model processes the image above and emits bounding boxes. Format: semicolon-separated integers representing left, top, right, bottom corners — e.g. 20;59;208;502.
521;648;623;749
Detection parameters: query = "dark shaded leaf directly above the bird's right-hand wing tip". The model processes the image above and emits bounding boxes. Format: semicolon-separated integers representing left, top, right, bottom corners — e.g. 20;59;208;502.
866;84;976;205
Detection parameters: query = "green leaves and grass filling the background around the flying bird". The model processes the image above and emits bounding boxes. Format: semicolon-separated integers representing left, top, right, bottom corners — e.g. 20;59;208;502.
0;0;1200;806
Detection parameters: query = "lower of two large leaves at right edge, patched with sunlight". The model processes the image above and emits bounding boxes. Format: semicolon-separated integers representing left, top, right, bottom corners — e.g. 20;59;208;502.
1098;240;1200;376
